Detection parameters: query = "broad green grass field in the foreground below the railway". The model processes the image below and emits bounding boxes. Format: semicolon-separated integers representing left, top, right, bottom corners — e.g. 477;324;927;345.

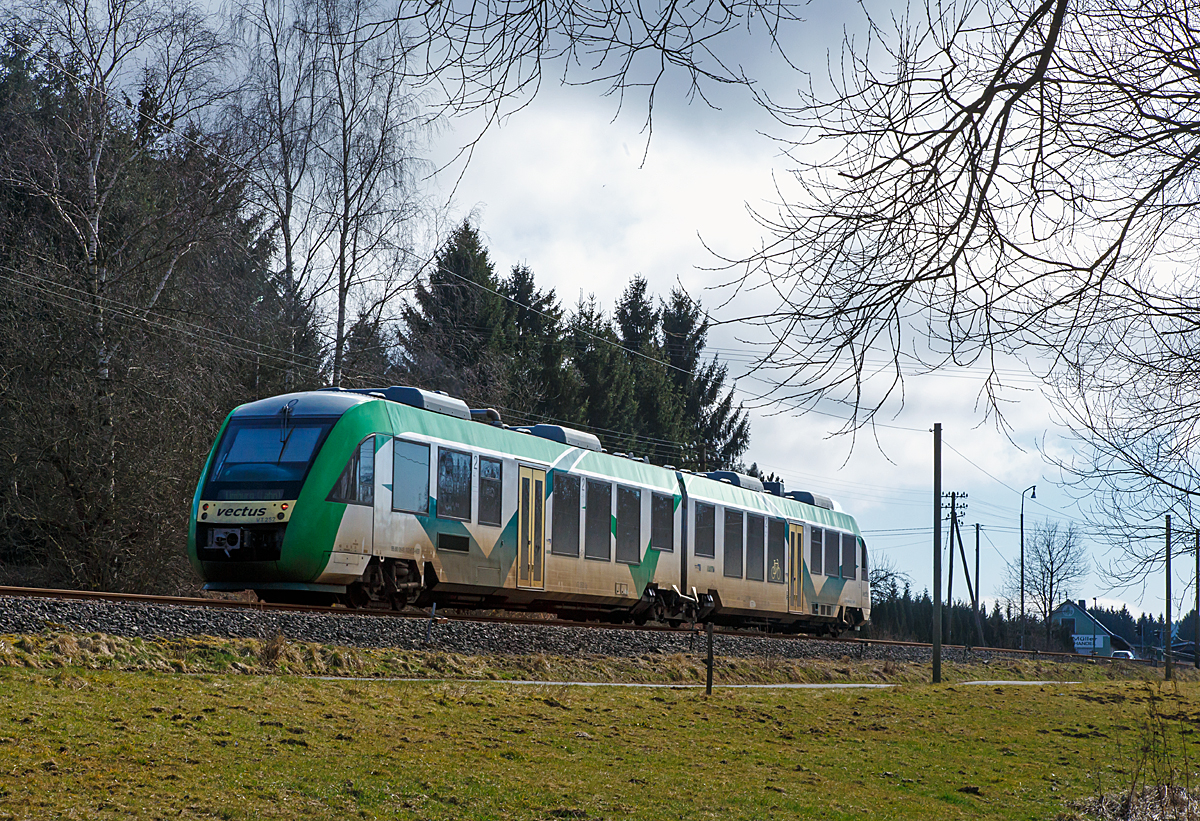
0;636;1200;821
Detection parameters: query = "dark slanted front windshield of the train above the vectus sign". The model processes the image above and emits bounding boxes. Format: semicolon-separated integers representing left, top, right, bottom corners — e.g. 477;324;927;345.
204;417;334;501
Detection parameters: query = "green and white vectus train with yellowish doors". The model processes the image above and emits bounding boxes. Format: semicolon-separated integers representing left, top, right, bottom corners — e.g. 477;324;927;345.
188;388;870;634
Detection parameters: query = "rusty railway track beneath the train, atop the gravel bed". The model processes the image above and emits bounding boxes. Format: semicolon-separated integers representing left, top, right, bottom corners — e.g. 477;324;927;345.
0;586;1113;660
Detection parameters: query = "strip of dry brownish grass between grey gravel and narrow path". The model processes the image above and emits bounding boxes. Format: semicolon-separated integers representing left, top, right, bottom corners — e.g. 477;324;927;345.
0;633;1185;684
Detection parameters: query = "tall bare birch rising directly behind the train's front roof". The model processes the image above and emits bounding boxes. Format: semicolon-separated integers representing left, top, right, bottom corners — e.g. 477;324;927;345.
226;0;433;385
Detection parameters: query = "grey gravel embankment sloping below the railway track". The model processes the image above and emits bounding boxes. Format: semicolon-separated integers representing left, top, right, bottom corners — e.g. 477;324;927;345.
0;597;1049;661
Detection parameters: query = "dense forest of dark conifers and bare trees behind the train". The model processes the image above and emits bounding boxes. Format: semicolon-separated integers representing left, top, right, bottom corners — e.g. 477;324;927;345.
0;16;750;592
